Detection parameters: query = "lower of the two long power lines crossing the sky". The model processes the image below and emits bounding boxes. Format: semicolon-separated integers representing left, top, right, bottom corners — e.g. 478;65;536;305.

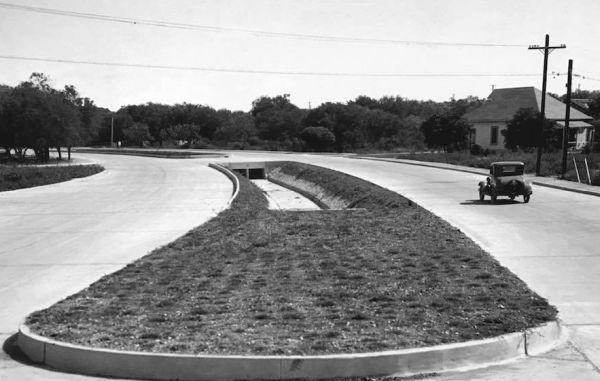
0;55;539;78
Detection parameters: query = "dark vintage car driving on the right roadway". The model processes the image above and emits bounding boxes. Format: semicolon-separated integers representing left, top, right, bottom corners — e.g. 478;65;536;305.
479;161;533;203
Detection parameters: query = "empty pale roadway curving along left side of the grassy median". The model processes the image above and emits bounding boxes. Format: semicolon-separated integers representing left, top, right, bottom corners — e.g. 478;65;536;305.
0;154;232;381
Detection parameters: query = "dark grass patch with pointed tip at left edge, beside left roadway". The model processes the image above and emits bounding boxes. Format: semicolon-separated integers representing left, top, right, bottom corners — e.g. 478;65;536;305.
0;164;104;192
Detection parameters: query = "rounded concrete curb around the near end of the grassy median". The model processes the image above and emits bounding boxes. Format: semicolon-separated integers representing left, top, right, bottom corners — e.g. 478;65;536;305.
17;321;565;380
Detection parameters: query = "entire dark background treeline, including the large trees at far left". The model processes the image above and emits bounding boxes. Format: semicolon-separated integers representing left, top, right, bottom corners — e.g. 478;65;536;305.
0;73;600;161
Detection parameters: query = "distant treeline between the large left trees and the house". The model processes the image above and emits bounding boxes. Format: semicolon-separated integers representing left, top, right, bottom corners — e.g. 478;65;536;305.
94;94;488;152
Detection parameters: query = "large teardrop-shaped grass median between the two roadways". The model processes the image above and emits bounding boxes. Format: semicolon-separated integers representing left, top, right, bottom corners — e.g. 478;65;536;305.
27;163;556;355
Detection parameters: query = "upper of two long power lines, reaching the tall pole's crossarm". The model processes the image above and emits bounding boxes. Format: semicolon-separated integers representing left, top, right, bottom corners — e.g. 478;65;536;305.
0;2;528;48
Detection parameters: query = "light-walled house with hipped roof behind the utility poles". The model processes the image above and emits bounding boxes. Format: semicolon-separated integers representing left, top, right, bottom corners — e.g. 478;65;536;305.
463;87;594;150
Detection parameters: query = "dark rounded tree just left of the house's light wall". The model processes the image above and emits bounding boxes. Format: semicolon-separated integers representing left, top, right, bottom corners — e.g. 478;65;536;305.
421;111;471;152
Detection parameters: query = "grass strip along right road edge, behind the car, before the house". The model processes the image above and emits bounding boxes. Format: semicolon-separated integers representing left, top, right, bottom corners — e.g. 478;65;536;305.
366;151;600;185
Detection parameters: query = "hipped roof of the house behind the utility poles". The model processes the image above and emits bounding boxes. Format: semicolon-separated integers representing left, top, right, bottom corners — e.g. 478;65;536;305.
463;87;593;122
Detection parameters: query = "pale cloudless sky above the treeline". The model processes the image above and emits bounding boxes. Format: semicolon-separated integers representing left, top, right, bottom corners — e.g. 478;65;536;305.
0;0;600;111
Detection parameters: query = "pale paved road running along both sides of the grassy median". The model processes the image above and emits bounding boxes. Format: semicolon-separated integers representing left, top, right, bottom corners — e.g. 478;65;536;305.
0;152;600;381
